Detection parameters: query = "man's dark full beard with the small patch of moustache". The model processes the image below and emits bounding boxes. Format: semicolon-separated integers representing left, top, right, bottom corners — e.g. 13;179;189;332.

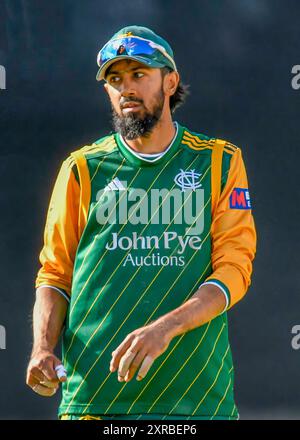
112;90;164;140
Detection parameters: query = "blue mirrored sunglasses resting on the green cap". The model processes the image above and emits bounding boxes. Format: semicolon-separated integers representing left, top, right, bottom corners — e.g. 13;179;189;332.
97;37;177;70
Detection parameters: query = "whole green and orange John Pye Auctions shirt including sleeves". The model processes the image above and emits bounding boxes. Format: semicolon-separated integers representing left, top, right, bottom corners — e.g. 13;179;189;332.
36;123;256;419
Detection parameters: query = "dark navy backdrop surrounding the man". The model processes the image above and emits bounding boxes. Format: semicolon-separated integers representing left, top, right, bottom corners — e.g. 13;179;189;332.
0;0;300;419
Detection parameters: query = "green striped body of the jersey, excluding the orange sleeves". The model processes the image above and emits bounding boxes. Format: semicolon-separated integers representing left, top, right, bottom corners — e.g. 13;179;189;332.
55;124;238;419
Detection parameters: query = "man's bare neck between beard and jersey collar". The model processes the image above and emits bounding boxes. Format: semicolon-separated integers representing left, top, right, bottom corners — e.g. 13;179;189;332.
125;114;176;154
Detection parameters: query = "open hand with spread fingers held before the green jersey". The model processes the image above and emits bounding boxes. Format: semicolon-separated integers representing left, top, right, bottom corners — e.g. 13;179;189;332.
110;323;172;382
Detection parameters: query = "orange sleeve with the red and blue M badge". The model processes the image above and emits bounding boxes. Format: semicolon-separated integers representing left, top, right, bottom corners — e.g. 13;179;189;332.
203;148;256;311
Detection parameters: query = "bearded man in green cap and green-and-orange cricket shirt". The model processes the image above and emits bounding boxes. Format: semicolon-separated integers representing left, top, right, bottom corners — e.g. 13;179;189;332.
27;26;256;419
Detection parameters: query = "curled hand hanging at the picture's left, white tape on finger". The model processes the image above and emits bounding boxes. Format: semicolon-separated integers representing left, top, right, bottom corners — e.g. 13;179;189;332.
26;350;67;397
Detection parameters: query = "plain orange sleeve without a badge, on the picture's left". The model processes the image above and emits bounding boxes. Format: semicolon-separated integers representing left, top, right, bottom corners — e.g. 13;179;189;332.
35;158;80;295
